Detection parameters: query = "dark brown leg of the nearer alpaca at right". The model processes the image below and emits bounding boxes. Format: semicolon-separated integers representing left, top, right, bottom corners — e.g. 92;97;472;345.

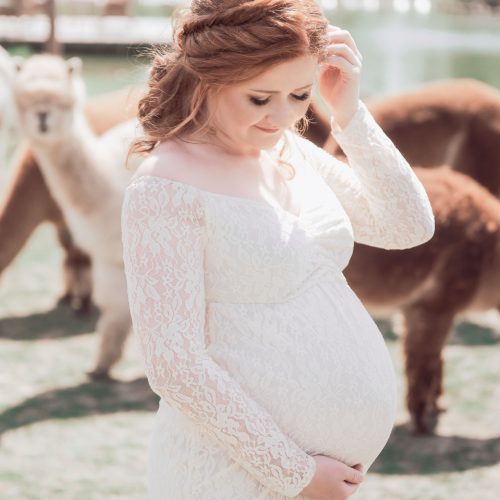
403;304;454;434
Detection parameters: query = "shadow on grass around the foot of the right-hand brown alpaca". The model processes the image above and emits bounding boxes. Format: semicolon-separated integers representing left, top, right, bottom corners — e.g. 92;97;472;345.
370;425;500;475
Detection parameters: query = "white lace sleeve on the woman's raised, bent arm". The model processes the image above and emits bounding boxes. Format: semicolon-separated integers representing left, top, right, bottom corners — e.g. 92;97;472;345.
292;101;434;249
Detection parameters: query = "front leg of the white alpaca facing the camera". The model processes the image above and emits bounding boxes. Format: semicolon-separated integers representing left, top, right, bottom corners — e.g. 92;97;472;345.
87;260;131;380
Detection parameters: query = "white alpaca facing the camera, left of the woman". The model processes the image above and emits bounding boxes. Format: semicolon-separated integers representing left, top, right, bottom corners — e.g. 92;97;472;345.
14;55;143;378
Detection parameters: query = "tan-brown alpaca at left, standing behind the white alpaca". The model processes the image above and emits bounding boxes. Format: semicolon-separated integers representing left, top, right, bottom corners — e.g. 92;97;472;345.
0;87;140;311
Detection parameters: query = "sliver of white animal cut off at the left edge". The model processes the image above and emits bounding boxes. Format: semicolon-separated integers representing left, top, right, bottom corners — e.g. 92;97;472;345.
0;46;16;168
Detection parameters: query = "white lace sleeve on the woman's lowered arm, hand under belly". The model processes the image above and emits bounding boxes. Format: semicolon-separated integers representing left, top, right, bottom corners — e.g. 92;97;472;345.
122;177;315;497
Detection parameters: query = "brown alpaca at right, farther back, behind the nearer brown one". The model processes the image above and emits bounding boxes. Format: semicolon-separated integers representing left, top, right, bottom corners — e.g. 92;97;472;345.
324;78;500;196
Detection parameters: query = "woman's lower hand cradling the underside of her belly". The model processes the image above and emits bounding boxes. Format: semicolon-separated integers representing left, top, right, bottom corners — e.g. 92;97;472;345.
300;455;363;500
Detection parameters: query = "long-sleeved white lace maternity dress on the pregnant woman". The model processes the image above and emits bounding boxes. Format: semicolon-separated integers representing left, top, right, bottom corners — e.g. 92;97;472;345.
122;101;434;500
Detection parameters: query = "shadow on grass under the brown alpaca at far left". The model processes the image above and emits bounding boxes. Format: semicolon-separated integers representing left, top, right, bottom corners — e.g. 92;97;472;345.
0;305;99;340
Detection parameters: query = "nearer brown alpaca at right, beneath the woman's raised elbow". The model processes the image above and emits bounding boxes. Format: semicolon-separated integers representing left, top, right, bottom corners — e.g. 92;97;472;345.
344;167;500;433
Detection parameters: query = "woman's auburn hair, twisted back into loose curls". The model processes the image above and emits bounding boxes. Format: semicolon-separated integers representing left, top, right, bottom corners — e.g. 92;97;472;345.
131;0;328;177
